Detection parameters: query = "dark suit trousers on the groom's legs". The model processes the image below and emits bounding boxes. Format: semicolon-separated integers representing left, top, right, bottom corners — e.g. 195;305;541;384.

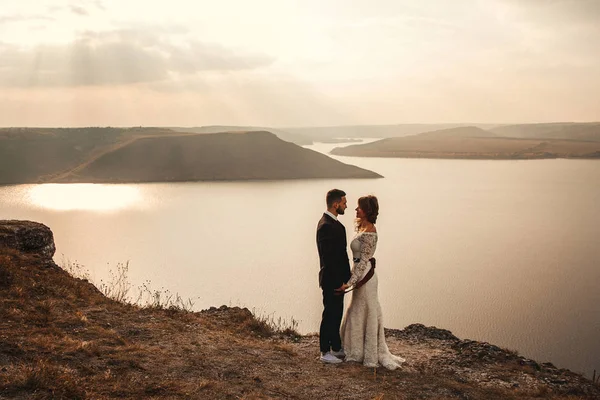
319;289;344;353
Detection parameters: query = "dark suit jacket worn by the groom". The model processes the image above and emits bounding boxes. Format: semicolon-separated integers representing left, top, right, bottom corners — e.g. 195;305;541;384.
317;214;350;289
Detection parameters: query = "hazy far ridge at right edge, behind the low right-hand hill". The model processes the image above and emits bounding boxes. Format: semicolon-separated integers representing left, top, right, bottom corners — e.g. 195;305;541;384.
491;122;600;141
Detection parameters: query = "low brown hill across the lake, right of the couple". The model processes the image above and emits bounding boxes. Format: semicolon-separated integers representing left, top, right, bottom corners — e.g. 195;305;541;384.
331;127;600;159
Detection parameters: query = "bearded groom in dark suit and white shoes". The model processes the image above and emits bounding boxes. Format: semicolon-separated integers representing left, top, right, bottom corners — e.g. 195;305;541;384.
317;189;350;364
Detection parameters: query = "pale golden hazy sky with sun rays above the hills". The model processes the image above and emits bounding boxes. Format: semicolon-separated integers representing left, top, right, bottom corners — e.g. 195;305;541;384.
0;0;600;127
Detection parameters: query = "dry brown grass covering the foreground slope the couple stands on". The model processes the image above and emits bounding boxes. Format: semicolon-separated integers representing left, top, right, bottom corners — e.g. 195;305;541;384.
0;253;600;400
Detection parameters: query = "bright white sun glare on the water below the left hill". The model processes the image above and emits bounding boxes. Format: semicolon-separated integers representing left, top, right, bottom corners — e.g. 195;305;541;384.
28;183;142;211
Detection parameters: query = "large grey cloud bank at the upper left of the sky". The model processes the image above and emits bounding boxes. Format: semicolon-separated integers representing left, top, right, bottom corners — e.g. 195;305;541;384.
0;30;274;87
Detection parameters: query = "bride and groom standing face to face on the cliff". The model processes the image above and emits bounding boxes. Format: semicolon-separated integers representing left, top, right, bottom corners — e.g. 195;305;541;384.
317;189;405;369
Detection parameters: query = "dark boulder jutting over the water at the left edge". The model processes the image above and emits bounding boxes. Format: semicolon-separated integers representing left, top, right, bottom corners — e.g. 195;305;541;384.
0;220;56;262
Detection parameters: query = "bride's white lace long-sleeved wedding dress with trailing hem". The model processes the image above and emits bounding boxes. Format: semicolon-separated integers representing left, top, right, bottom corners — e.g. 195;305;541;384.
341;232;405;369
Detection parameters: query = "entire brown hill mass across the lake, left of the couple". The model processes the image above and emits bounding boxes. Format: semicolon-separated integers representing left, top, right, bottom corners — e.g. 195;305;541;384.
0;128;380;184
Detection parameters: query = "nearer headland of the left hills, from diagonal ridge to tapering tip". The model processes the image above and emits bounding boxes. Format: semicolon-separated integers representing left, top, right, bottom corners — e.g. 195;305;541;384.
58;131;381;182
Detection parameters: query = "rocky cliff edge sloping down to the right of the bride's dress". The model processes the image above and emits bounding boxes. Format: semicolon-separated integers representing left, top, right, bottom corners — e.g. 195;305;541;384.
385;324;600;399
